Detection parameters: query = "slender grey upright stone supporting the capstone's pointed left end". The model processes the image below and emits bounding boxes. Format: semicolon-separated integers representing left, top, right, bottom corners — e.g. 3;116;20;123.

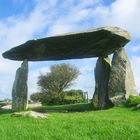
12;60;28;111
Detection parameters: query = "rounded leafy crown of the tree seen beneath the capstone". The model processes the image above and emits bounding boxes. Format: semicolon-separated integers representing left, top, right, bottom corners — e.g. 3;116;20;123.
38;64;79;94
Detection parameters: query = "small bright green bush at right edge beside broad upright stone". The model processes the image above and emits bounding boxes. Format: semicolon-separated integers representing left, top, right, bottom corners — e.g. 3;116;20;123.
126;95;140;107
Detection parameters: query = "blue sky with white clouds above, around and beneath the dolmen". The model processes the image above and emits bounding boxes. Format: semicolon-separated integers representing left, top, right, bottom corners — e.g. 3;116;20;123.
0;0;140;100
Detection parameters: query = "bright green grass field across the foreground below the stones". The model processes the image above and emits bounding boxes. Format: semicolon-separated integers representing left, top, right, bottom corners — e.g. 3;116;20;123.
0;106;140;140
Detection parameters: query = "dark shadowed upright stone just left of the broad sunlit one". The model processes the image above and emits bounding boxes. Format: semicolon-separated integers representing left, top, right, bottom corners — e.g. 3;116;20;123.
93;57;112;109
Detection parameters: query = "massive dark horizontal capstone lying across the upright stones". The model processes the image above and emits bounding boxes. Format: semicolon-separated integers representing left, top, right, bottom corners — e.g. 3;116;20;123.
3;27;131;61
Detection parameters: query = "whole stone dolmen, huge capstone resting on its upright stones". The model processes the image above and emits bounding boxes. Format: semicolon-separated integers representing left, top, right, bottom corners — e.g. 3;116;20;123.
2;27;137;111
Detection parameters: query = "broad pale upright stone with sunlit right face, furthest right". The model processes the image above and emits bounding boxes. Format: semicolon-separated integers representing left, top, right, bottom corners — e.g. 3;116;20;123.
108;48;137;105
